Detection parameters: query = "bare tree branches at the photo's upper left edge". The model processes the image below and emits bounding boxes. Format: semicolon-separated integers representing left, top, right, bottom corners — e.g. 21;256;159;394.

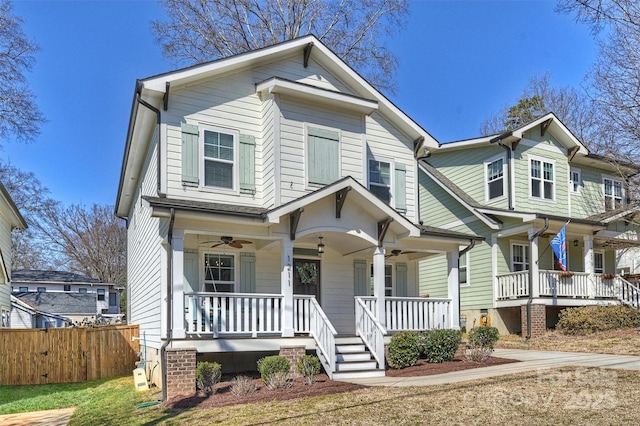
0;0;45;142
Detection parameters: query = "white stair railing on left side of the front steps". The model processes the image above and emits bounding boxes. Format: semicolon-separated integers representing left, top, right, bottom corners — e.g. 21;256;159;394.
293;295;338;375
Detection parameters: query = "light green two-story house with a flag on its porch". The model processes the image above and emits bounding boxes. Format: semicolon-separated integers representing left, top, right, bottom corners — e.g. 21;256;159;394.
419;113;640;335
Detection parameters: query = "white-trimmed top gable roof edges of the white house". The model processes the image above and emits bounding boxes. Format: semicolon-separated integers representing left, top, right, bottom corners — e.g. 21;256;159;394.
116;35;438;217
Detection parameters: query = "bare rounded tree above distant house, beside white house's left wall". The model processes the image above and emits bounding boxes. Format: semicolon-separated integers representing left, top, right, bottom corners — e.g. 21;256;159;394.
36;203;127;285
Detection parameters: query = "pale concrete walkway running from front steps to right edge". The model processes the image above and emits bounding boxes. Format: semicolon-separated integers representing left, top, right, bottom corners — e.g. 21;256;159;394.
336;349;640;387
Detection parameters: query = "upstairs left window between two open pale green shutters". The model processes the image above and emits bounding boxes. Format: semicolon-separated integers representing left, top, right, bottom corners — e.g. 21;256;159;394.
201;129;236;189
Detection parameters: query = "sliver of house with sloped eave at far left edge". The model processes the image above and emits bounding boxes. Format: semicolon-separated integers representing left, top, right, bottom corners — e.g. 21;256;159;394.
0;183;27;327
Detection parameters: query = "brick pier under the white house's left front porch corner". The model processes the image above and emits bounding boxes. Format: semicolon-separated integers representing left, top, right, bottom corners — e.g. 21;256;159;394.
165;349;196;399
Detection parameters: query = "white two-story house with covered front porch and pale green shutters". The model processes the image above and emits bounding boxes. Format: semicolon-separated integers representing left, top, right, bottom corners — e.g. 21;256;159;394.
116;36;477;396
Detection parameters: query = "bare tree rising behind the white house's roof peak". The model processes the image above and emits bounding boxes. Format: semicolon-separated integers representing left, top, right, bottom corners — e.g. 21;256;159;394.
152;0;409;92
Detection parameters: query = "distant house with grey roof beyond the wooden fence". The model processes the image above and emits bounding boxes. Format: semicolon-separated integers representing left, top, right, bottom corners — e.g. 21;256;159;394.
11;270;122;320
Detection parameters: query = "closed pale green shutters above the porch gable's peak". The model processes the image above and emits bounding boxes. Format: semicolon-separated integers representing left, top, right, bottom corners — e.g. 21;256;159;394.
307;127;340;185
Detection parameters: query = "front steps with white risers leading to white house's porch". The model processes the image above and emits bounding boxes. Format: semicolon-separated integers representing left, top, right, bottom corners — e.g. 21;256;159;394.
333;336;384;380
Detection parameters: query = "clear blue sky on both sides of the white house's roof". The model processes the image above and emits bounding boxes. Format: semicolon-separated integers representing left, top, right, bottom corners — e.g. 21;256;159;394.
0;0;596;205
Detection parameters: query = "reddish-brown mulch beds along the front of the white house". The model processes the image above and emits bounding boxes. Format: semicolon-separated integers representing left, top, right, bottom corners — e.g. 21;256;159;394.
165;356;517;409
